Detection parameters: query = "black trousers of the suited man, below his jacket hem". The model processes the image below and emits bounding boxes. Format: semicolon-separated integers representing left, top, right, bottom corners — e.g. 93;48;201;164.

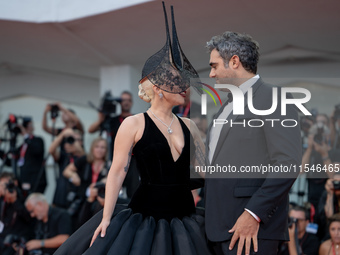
209;239;279;255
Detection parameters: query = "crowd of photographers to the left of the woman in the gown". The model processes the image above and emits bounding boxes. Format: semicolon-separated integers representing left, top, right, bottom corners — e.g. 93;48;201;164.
0;91;139;255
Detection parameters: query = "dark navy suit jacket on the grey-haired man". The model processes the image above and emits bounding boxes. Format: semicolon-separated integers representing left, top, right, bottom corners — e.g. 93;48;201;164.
205;79;302;242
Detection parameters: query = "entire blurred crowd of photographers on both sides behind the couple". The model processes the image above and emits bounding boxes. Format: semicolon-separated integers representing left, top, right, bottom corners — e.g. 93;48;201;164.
0;91;340;255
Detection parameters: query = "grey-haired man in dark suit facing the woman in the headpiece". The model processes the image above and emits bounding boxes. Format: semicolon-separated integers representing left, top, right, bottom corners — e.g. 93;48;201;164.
205;32;301;255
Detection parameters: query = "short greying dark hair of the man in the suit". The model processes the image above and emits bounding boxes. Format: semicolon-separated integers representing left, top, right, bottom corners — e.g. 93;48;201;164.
206;31;260;74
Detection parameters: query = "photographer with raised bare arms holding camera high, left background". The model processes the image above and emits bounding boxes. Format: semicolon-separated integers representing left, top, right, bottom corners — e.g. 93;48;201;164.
42;103;84;135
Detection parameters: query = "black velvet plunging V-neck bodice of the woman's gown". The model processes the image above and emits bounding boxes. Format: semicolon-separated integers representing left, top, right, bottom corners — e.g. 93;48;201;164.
129;113;195;221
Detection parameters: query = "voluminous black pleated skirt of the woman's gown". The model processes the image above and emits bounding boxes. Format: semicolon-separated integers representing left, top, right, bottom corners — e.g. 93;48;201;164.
54;205;210;255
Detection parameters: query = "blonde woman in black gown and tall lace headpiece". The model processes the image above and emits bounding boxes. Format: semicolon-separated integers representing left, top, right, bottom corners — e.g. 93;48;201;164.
55;2;209;255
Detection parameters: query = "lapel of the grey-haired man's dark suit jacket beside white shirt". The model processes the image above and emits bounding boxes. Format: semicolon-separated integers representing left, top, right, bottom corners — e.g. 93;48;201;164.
209;78;263;164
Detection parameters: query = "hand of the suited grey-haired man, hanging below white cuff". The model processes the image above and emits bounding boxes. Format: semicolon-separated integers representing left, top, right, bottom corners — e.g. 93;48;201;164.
229;211;260;255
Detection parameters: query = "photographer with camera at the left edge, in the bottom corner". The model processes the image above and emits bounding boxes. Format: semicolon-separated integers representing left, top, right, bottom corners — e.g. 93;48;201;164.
0;172;33;255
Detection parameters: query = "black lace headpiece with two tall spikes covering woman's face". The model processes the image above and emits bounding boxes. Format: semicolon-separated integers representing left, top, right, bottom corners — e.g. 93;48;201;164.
140;2;198;94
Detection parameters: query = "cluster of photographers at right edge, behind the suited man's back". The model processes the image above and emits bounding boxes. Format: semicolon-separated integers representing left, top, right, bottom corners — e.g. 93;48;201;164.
279;105;340;255
